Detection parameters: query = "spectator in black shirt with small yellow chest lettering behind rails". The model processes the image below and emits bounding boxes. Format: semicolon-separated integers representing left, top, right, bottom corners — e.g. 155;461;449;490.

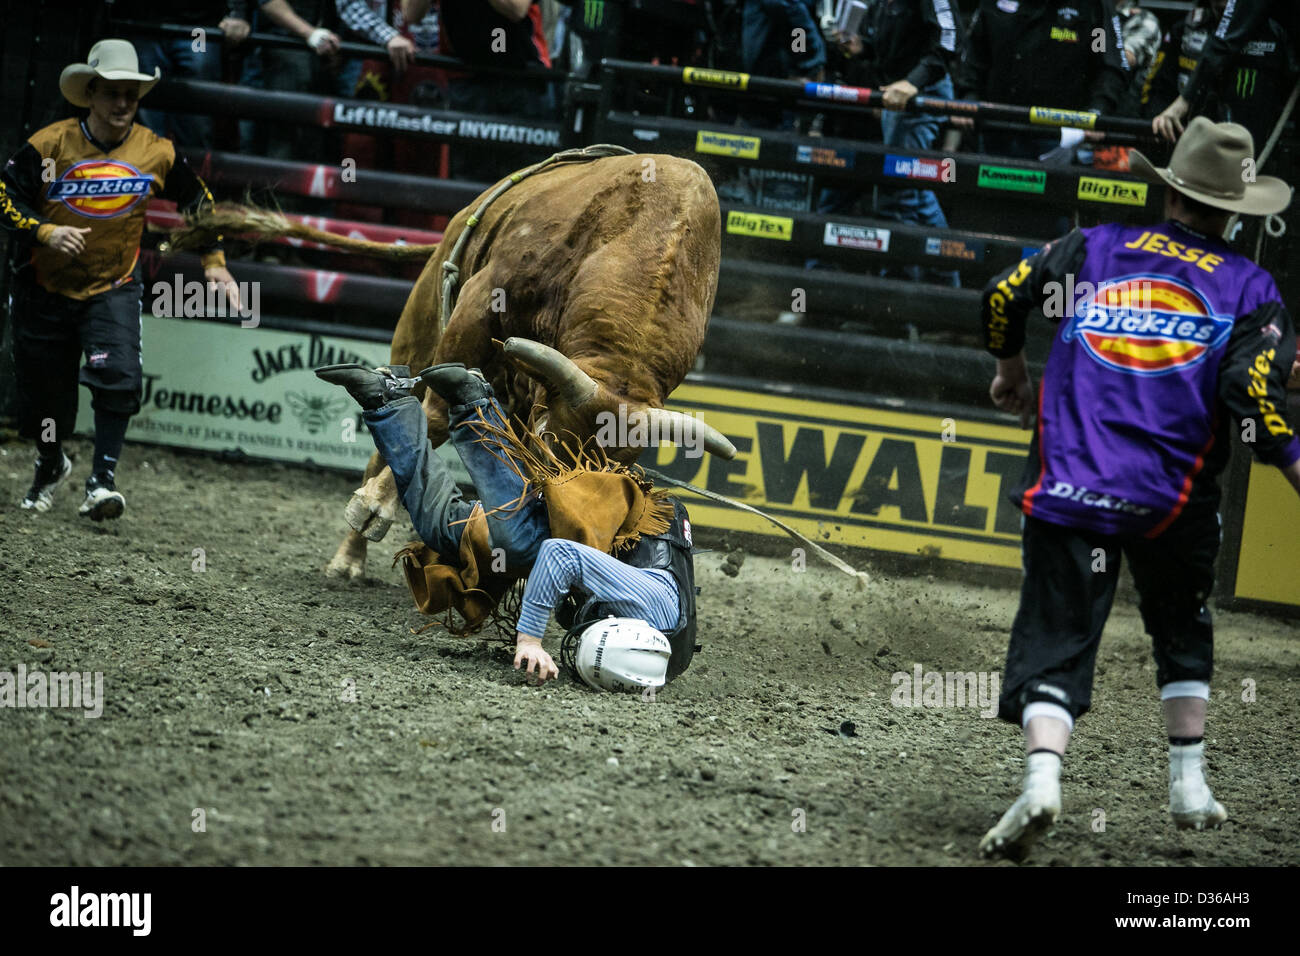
953;0;1130;160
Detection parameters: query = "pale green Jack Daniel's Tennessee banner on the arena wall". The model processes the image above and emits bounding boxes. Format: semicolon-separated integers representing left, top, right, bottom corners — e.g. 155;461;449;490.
69;315;464;475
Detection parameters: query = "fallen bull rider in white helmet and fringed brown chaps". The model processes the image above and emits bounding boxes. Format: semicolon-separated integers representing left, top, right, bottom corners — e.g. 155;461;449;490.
316;363;697;692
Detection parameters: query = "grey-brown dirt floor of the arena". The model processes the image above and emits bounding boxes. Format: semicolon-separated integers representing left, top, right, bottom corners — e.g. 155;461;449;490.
0;442;1300;866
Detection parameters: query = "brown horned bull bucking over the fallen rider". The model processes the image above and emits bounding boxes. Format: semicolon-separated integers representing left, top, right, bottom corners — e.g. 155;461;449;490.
317;155;735;578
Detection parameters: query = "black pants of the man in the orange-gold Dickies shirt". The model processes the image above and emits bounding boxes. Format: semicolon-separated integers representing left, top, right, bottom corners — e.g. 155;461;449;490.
10;277;143;441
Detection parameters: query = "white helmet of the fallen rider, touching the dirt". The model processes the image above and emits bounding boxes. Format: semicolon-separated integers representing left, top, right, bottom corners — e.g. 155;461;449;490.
560;617;672;693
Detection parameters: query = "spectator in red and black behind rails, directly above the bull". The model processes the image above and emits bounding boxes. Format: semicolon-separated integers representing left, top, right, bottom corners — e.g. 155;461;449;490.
402;0;555;181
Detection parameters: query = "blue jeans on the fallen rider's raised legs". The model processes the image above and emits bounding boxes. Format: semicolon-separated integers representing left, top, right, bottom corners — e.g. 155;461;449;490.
361;395;550;568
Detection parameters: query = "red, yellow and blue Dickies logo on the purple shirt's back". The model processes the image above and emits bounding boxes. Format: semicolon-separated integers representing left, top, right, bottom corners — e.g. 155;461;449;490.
1062;274;1232;376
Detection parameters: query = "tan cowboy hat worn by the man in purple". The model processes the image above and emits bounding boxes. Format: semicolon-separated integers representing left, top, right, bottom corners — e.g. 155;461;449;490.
1128;116;1291;216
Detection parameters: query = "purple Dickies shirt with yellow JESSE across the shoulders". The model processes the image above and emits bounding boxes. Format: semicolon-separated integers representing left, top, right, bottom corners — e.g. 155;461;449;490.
1022;222;1300;535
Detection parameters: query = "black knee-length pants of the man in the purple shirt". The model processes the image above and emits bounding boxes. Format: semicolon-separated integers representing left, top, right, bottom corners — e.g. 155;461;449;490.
998;502;1219;724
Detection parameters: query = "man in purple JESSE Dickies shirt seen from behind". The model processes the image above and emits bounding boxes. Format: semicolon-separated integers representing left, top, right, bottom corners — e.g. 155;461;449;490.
980;117;1300;856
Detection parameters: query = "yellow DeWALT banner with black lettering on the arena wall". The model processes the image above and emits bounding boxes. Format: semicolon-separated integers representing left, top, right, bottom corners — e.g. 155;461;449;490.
654;382;1028;567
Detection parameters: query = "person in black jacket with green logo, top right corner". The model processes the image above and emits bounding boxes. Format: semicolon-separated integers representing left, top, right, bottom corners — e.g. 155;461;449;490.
1143;0;1296;151
